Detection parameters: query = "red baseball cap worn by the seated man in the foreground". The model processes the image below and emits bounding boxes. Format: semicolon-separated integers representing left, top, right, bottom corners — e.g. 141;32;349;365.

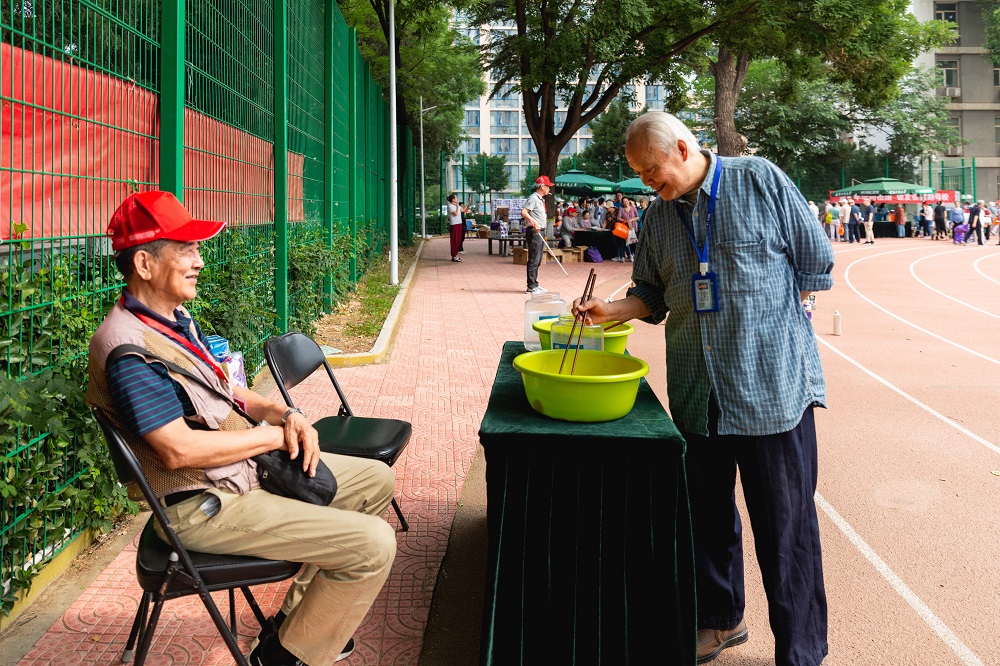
107;190;226;252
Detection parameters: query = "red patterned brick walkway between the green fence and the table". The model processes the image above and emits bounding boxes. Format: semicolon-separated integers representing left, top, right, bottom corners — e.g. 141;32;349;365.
15;231;632;666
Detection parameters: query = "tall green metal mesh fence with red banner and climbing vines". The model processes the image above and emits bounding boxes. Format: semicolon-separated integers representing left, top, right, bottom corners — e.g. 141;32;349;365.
0;0;406;612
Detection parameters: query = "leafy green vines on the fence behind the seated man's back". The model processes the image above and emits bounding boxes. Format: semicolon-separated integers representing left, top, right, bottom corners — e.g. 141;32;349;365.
0;250;138;615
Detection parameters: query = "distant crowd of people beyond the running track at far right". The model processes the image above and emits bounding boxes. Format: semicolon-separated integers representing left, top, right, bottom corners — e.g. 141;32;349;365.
809;197;1000;245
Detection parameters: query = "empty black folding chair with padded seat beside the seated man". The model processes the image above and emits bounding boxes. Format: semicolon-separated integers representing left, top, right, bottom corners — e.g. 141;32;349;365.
264;331;413;532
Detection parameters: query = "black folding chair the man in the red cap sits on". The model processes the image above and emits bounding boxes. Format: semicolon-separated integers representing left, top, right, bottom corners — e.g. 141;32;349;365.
93;408;302;666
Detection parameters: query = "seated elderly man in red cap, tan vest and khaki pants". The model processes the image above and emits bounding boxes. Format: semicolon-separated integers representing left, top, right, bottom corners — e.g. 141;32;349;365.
87;192;396;666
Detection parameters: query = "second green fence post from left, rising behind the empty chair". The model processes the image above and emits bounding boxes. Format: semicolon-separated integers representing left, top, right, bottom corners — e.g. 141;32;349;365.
273;0;288;333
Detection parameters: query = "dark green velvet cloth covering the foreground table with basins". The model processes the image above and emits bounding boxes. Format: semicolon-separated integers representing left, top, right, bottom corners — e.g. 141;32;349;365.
479;342;697;666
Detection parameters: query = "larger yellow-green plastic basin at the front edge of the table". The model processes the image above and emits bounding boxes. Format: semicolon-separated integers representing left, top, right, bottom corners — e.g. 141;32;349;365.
514;349;649;423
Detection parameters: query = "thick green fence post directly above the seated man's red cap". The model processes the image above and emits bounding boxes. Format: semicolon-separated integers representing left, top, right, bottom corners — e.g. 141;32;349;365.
160;0;186;195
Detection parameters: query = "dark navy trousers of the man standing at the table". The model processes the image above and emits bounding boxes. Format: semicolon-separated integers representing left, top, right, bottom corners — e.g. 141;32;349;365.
683;397;828;666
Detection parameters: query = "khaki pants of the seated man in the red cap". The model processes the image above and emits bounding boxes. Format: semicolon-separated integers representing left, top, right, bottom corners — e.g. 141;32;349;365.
166;453;396;666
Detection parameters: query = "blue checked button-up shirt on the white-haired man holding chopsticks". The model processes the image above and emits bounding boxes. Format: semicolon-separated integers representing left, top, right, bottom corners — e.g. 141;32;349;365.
629;151;833;435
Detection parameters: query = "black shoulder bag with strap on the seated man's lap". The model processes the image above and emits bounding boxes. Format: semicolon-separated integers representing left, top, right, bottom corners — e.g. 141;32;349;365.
106;345;337;506
